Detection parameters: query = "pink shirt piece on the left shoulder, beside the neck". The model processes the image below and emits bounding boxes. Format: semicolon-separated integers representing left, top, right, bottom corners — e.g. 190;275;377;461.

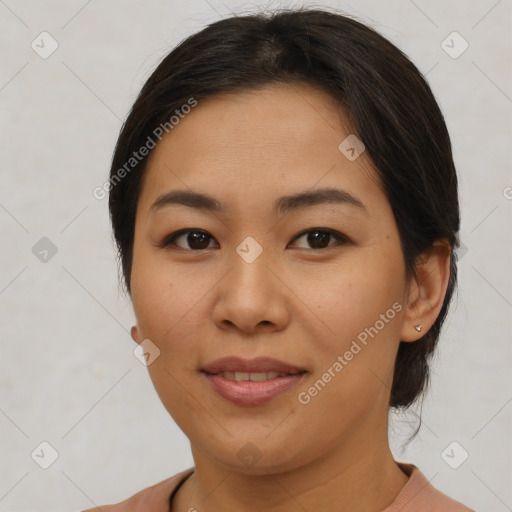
82;468;194;512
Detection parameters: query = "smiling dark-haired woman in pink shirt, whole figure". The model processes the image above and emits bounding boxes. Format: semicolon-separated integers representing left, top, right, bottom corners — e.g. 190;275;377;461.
86;9;470;512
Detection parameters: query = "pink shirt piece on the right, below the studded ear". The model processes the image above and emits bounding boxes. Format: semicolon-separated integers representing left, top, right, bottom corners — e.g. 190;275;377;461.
384;464;474;512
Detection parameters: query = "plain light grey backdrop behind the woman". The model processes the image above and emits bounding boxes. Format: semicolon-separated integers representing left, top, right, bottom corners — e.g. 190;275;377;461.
0;0;512;512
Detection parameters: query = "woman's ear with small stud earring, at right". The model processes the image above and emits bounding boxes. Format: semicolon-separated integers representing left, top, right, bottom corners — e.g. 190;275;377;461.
400;239;451;341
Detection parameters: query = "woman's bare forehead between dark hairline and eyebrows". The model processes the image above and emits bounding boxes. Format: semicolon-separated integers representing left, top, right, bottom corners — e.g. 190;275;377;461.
136;84;384;215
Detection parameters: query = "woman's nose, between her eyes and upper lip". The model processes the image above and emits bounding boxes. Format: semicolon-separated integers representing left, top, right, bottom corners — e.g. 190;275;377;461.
212;245;293;334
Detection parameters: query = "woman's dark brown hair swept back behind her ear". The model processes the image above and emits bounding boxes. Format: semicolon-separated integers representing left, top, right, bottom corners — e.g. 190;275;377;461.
109;8;460;408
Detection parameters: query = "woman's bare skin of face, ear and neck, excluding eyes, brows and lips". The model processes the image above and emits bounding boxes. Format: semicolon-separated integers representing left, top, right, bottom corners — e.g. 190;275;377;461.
131;84;449;512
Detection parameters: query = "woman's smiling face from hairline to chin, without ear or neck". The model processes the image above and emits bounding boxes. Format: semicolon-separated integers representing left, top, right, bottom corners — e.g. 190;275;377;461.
131;85;408;474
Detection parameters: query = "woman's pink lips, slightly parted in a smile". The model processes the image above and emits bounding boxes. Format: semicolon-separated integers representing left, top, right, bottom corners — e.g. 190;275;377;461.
201;357;308;405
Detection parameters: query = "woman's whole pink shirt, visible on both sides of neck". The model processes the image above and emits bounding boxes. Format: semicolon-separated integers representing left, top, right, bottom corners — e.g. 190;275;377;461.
83;464;475;512
